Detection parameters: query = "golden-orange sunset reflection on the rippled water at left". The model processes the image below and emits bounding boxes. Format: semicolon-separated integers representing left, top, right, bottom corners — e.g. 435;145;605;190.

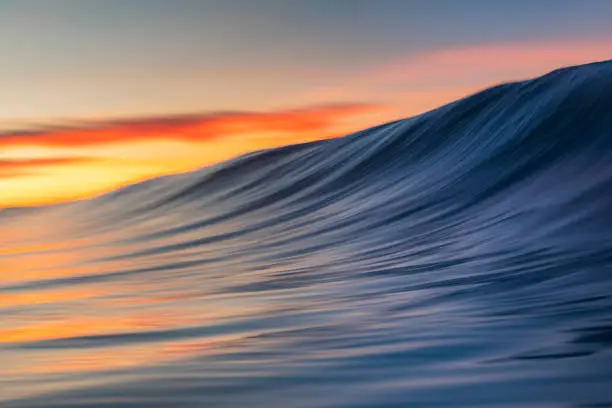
0;210;274;404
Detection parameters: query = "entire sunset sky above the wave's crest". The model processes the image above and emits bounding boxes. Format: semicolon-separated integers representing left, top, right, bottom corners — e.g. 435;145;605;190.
0;0;612;208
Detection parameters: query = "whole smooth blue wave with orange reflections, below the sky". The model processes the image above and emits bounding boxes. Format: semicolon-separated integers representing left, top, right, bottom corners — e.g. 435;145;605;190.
0;62;612;408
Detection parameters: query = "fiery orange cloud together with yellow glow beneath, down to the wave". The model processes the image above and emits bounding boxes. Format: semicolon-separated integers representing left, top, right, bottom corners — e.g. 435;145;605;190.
0;104;385;207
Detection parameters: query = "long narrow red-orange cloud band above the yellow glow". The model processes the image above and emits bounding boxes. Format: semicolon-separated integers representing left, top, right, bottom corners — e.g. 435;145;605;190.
0;104;382;147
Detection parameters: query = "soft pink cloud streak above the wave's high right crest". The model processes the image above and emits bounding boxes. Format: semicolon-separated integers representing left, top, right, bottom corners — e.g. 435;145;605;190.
302;38;612;117
